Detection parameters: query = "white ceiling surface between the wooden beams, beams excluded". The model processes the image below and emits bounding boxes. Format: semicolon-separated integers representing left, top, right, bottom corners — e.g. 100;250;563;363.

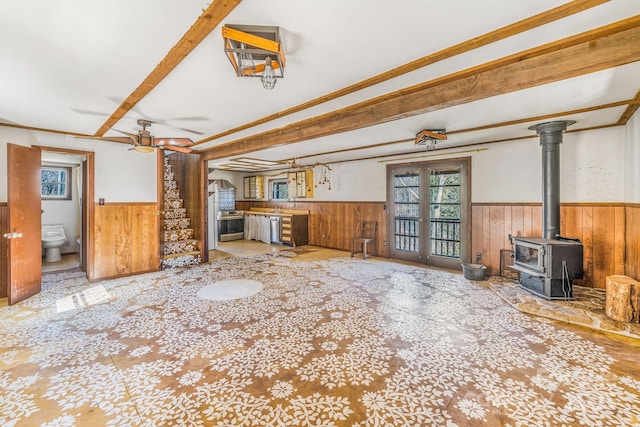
0;0;640;171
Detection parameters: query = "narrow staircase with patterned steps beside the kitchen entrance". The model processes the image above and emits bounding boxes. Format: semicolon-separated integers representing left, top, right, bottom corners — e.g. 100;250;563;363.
161;156;202;270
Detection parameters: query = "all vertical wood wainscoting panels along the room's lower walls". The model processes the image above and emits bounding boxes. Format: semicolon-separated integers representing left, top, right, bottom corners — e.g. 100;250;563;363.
0;201;640;298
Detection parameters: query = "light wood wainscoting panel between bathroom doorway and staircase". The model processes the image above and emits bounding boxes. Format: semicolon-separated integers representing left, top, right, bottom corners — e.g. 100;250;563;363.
89;203;160;280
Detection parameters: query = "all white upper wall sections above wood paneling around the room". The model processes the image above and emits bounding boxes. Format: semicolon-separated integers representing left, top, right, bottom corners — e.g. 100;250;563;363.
0;123;628;207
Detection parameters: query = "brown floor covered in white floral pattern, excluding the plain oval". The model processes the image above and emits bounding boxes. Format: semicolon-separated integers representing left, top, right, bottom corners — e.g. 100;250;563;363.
0;251;640;427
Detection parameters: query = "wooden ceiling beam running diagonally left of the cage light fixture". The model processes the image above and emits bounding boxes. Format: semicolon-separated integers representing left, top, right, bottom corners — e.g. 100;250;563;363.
95;0;242;136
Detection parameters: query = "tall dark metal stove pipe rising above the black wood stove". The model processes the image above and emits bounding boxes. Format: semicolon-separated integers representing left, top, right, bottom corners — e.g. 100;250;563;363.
529;120;575;239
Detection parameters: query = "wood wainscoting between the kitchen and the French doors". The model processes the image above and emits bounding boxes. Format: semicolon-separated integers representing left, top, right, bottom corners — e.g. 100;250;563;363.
236;201;389;258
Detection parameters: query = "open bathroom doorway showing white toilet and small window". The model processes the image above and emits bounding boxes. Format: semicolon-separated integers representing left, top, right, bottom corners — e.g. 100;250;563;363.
40;147;93;273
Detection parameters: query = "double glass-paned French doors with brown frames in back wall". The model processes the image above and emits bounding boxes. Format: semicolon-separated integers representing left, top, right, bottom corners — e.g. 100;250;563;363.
387;158;471;270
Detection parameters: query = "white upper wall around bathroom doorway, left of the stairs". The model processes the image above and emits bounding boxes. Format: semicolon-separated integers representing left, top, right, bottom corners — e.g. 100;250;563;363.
0;126;157;203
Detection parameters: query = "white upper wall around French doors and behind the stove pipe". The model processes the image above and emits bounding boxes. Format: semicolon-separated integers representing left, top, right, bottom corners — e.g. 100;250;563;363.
230;126;624;203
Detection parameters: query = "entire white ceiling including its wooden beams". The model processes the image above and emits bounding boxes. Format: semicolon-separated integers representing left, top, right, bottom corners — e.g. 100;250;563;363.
0;0;640;169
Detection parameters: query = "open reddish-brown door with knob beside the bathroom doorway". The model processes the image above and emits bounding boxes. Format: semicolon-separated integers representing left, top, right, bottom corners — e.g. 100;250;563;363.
4;144;42;305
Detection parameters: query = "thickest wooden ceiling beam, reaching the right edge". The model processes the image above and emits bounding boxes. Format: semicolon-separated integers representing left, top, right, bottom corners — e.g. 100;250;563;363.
204;15;640;160
